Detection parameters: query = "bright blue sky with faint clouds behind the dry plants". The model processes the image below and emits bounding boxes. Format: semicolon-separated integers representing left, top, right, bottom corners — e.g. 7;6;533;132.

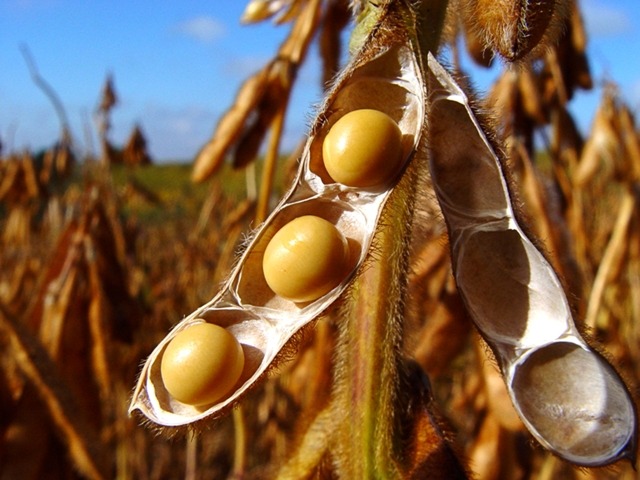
0;0;640;161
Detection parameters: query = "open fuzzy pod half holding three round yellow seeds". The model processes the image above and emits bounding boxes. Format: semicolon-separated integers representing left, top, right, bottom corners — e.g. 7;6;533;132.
130;2;425;427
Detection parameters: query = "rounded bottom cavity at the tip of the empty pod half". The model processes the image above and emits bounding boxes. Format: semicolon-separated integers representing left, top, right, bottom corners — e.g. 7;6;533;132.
513;342;635;466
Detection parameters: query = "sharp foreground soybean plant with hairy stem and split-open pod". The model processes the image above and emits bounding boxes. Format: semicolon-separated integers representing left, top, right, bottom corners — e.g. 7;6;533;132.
130;0;637;479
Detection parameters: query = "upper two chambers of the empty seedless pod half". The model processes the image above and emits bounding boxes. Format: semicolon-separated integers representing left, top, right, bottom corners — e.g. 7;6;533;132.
429;57;577;354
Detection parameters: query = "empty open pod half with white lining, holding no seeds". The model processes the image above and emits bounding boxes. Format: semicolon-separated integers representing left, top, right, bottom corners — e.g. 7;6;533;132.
427;57;636;467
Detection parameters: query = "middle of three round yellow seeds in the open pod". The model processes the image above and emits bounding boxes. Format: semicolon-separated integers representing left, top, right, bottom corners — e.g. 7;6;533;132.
262;215;349;302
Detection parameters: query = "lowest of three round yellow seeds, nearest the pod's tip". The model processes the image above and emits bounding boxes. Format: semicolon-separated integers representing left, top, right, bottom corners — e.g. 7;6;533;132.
160;323;244;405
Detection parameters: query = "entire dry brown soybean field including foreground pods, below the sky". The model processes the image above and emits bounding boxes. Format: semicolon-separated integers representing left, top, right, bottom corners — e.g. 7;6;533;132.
0;0;640;480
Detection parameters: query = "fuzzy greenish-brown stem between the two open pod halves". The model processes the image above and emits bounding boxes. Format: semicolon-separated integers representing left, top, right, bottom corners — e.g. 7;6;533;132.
336;157;417;479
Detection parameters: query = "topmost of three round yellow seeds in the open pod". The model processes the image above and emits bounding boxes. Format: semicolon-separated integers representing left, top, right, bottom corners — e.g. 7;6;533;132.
322;109;403;187
